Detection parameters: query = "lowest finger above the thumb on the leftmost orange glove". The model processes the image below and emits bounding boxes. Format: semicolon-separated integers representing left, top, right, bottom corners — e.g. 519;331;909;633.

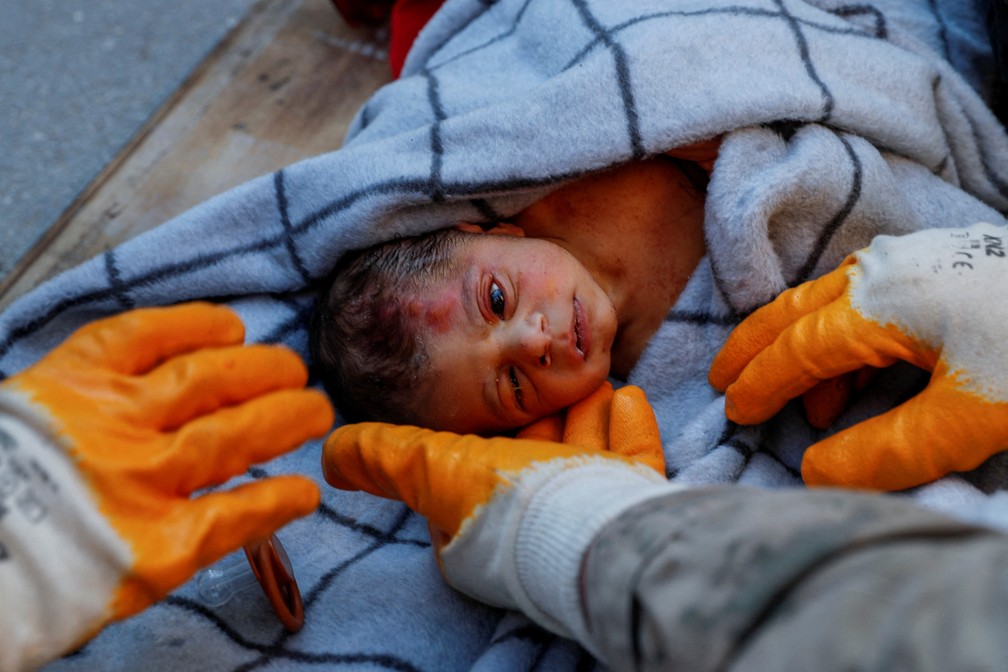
163;390;334;493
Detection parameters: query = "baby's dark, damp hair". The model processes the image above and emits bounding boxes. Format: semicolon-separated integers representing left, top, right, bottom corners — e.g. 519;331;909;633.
308;229;473;424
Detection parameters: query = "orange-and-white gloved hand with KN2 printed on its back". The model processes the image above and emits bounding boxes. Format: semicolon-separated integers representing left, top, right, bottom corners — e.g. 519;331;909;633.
710;224;1008;490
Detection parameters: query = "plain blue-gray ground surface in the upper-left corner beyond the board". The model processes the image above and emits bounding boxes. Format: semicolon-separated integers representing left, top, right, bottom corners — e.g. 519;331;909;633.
0;0;255;278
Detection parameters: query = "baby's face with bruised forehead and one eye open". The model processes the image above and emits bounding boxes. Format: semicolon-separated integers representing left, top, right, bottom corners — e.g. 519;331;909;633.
409;236;617;433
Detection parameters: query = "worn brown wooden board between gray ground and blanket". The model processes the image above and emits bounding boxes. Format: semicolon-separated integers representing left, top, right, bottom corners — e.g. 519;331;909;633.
0;0;390;310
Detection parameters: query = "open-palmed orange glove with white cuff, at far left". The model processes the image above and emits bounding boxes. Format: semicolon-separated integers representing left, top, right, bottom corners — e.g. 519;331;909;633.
0;304;333;670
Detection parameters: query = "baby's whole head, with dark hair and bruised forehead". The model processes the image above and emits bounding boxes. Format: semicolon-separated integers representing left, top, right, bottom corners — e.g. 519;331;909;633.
310;230;616;433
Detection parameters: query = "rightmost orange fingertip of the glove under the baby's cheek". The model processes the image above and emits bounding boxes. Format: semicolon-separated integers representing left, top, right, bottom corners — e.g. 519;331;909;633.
609;385;665;476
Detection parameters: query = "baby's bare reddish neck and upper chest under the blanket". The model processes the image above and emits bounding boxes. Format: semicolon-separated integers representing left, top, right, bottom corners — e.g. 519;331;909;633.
515;157;706;378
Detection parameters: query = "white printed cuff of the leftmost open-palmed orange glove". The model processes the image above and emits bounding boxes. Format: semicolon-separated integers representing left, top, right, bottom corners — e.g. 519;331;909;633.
0;392;131;672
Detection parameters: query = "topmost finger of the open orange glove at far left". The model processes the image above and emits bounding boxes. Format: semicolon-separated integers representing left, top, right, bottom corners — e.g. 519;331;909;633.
57;302;245;375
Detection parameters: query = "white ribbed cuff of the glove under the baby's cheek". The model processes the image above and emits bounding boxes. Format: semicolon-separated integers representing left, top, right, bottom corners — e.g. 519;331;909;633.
440;456;673;653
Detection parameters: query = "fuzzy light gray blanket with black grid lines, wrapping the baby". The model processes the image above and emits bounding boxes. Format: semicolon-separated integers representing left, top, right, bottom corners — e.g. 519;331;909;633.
0;0;1008;671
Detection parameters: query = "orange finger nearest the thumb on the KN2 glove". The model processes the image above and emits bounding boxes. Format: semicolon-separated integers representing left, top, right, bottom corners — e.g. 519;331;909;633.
725;299;922;424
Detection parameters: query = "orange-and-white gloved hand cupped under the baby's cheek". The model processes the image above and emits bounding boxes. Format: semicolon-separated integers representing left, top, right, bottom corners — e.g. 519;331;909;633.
323;383;667;636
